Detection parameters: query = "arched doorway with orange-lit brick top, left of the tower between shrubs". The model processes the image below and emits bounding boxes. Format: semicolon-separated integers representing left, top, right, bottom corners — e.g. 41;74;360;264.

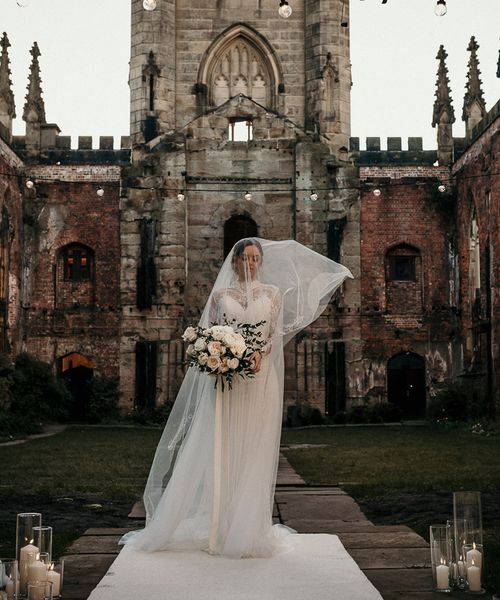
59;352;96;421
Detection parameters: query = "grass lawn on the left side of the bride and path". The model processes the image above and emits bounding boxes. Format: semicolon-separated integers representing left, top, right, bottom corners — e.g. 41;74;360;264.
0;427;161;557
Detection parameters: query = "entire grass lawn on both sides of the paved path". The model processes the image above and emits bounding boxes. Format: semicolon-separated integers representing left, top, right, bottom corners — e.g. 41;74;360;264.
0;426;500;593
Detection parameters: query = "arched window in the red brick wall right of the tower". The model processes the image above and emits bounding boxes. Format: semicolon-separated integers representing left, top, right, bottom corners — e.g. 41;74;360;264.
385;244;422;314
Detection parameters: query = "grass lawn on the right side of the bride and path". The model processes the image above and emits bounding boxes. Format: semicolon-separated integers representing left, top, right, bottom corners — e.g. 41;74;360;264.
282;425;500;593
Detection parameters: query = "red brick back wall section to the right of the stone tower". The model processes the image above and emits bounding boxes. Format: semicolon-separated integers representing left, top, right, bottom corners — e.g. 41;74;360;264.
360;166;459;408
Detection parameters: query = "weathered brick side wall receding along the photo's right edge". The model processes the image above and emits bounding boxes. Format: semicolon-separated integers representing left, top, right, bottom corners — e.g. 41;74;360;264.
453;104;500;413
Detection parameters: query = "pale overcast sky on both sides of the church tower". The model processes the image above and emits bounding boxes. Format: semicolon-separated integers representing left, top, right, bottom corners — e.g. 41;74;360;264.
0;0;500;149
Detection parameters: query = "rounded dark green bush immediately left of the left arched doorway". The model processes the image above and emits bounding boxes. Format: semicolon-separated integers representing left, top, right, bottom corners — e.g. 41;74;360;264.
10;352;71;422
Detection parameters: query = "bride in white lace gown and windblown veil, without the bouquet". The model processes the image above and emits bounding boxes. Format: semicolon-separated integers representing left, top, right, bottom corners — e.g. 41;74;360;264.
124;238;352;558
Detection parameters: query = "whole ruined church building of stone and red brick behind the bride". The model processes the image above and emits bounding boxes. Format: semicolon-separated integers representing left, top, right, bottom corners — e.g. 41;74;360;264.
0;0;500;418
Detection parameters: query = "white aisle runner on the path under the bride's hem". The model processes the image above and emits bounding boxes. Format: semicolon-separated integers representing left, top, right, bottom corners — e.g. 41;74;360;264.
89;534;382;600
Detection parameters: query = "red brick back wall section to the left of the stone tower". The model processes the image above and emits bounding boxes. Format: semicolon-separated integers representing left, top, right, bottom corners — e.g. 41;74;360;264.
24;166;120;376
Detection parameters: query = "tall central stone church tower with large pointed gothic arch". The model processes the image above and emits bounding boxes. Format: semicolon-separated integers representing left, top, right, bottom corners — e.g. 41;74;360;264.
120;0;360;413
